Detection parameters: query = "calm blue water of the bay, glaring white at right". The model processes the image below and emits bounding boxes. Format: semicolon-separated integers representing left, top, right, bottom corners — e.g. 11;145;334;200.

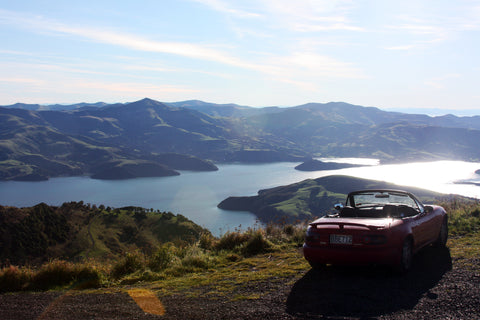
0;159;480;235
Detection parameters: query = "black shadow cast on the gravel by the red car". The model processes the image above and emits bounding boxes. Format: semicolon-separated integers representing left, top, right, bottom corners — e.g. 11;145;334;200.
286;247;452;319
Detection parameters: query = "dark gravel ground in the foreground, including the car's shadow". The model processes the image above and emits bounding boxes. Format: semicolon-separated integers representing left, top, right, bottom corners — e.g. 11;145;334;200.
0;248;480;320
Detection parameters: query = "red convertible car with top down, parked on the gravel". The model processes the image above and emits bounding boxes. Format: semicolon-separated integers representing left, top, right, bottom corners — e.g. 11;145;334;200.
303;189;448;272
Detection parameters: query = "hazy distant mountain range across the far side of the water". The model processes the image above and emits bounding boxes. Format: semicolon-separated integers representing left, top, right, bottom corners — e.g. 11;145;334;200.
0;98;480;180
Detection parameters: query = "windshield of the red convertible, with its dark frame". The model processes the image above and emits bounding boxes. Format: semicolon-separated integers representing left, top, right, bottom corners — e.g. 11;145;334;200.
347;191;418;209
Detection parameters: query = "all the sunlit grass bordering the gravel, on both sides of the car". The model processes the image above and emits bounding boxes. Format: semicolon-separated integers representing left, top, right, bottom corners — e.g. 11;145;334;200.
0;201;480;300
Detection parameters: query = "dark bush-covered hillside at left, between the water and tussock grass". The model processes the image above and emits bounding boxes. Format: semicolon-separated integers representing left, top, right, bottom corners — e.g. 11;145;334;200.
0;202;210;264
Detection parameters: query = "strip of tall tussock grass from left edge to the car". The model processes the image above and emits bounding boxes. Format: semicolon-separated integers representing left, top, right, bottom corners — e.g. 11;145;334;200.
0;224;305;292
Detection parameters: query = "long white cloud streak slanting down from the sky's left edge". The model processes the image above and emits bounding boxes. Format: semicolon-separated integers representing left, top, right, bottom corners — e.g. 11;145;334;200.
0;10;361;86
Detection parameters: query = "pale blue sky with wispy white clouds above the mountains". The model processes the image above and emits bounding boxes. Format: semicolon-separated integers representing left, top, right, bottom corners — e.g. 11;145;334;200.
0;0;480;115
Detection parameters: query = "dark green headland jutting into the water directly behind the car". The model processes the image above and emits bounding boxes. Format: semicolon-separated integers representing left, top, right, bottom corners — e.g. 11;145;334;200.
218;176;454;223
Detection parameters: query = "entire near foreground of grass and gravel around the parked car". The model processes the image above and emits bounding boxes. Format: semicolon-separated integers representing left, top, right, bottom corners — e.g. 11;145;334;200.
0;200;480;320
